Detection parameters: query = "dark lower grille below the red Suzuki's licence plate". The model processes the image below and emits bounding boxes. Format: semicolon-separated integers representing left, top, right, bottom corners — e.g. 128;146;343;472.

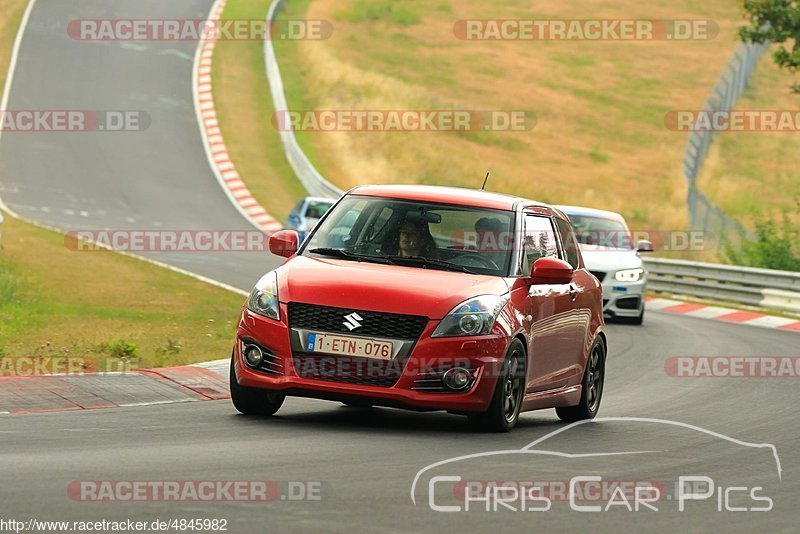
292;352;404;387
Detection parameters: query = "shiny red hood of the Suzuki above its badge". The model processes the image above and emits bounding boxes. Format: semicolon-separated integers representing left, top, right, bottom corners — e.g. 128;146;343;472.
277;256;508;319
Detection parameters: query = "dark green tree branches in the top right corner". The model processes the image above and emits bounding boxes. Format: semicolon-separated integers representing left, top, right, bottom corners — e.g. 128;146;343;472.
739;0;800;93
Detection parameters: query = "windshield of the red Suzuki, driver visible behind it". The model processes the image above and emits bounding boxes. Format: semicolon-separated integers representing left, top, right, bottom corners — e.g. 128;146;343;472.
301;195;514;276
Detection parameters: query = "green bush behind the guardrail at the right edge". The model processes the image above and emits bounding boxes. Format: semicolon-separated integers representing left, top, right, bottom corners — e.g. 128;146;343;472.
725;213;800;271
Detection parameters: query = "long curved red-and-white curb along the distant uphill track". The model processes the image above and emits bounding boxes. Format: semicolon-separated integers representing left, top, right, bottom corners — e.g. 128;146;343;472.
193;0;282;233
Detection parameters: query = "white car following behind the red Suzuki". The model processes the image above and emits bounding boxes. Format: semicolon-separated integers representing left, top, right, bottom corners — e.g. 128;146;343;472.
556;206;653;324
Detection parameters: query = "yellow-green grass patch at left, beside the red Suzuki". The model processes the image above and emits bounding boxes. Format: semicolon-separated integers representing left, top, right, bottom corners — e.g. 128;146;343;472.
0;217;243;371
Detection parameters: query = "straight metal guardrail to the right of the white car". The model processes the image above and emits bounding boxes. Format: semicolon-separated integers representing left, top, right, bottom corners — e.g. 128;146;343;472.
644;258;800;312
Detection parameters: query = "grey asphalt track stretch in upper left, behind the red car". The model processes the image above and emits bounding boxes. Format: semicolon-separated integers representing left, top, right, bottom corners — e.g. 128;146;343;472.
0;0;280;289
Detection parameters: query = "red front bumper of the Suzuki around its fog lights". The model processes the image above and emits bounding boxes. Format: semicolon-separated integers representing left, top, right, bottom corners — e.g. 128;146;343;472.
234;304;510;413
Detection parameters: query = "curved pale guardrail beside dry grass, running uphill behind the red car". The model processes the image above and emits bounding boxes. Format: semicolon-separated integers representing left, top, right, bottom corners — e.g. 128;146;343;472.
264;0;342;198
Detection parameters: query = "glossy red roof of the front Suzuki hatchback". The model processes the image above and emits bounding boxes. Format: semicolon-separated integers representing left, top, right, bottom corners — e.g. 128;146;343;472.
348;185;551;211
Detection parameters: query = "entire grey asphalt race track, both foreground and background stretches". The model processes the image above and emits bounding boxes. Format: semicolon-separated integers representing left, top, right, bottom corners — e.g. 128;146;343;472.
0;0;800;533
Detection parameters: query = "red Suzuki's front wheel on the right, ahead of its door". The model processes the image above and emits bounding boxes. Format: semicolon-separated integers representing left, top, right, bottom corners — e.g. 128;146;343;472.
468;339;525;432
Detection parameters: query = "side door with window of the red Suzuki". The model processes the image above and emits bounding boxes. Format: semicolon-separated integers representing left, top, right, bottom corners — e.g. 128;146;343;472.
520;212;583;393
